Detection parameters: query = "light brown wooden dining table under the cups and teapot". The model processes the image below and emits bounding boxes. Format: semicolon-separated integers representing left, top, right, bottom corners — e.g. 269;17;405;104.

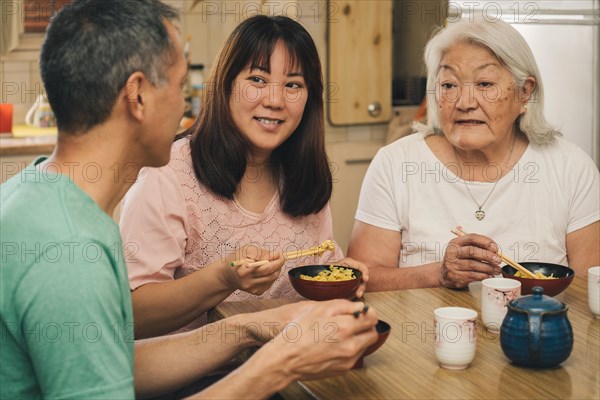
212;276;600;399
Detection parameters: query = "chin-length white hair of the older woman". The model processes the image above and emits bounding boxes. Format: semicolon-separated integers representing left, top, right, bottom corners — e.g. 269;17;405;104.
416;18;561;144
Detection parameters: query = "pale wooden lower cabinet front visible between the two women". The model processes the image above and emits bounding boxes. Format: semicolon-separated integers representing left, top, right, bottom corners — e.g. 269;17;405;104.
327;141;383;254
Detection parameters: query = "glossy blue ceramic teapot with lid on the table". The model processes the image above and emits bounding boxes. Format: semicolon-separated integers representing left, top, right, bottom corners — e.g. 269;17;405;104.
500;286;573;368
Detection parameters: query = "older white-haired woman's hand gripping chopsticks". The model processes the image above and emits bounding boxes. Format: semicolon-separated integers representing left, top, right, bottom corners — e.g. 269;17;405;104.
440;233;502;288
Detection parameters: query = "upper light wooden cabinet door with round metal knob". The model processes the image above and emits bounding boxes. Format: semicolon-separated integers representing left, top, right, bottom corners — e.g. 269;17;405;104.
327;0;392;125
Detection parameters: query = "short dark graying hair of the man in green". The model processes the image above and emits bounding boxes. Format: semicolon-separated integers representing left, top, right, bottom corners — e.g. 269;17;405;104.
40;0;179;133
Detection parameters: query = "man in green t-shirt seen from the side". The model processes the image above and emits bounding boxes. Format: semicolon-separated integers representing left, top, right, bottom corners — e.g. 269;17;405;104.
0;0;377;399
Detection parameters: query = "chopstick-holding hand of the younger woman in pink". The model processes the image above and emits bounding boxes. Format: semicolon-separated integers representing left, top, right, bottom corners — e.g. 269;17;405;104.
222;246;285;296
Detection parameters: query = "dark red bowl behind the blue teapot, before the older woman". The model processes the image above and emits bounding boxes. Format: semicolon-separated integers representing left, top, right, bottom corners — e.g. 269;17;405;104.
502;262;575;296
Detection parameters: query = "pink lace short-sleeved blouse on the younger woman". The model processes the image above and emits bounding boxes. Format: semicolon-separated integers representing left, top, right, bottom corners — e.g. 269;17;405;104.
120;139;343;322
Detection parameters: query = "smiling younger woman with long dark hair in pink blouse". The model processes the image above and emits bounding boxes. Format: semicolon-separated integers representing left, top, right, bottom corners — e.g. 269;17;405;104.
120;16;368;337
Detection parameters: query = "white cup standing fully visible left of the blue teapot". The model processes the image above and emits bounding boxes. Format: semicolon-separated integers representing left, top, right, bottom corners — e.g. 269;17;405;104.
433;307;477;369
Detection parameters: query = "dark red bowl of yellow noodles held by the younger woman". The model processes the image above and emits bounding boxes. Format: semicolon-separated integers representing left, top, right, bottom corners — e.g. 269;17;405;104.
288;264;362;300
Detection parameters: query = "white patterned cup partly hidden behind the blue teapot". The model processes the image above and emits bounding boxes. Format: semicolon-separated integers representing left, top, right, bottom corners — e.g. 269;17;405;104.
481;278;521;332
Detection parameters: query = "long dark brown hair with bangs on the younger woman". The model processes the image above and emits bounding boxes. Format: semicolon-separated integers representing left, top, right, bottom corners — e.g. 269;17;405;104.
181;15;332;217
